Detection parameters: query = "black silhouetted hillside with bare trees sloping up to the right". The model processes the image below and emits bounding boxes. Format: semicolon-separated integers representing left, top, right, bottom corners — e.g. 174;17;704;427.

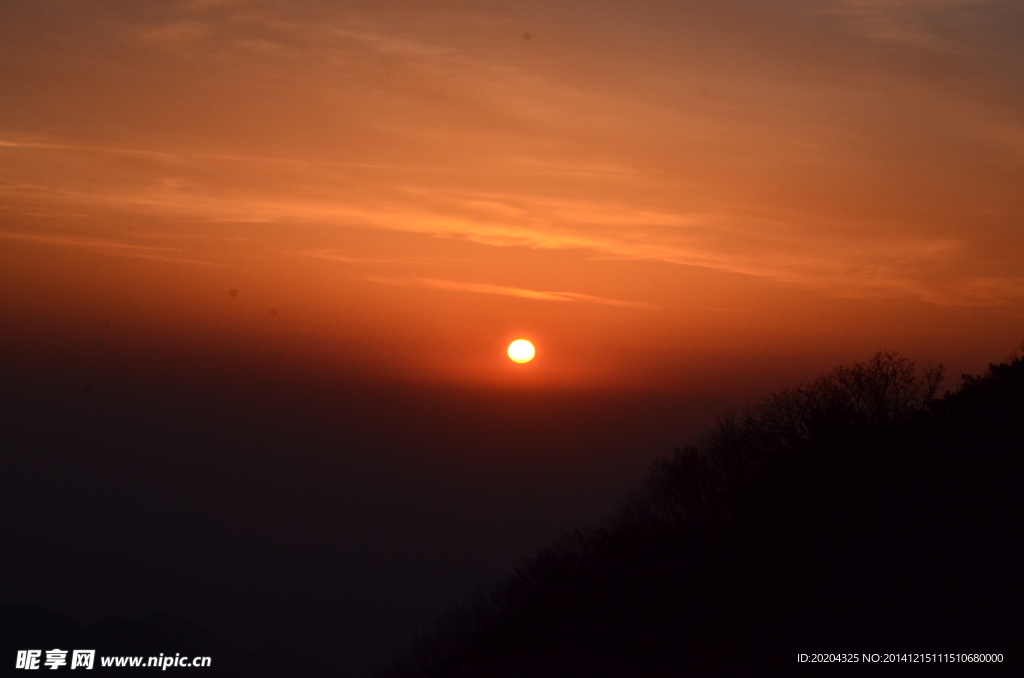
389;353;1024;677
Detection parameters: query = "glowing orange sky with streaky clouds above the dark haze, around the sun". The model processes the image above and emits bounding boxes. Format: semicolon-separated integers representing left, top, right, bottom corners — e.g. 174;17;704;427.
0;0;1024;390
